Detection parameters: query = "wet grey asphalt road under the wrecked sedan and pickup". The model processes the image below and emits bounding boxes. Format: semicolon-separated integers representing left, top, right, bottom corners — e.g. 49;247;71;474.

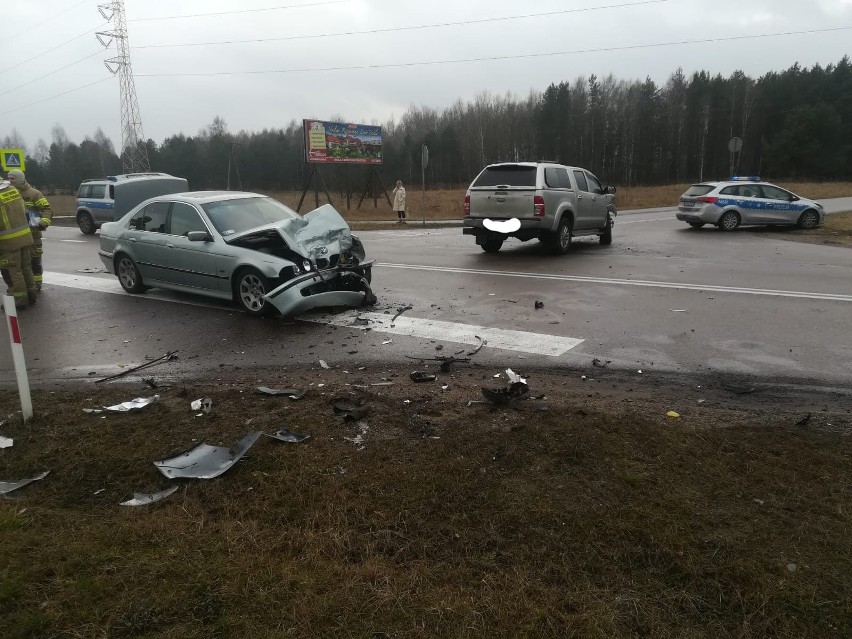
0;198;852;386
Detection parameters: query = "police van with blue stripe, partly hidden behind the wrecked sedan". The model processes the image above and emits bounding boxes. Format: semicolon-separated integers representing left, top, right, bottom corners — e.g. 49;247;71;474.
77;173;189;235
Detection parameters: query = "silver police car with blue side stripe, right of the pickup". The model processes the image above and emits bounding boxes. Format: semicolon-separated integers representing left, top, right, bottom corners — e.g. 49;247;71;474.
677;176;825;231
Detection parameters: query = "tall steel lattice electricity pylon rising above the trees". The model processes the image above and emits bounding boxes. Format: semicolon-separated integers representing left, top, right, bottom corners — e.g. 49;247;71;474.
95;0;151;173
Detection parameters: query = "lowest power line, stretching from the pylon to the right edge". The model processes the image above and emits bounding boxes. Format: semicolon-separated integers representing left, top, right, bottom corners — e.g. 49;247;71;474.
136;26;852;78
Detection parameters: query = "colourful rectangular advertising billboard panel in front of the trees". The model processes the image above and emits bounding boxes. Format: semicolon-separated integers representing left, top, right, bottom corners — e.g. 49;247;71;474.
303;120;382;164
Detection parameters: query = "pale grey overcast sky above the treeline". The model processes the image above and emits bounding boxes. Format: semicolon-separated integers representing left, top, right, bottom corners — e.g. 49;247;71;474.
0;0;852;151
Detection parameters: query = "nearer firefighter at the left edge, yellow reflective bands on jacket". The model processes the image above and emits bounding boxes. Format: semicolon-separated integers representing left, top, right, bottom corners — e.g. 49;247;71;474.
0;180;38;308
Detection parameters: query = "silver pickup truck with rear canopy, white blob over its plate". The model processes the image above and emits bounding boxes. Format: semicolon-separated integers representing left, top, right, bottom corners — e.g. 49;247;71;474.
462;162;618;254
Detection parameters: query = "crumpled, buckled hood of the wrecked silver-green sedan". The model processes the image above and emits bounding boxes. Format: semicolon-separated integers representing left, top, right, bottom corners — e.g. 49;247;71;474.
225;204;354;261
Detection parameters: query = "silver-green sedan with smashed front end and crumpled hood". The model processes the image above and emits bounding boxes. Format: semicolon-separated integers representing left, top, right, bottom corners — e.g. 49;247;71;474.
98;191;375;317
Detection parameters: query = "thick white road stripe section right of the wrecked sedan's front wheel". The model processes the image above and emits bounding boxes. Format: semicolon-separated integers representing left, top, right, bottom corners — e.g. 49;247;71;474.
299;311;583;357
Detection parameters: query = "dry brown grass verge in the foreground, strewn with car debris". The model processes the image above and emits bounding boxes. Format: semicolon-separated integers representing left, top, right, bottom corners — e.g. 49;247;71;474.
0;368;852;639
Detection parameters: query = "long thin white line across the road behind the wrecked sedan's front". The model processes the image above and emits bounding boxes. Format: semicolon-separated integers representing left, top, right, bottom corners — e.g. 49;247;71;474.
375;263;852;302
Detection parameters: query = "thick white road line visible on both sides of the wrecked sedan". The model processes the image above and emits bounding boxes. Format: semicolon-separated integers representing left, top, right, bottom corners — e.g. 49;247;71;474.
44;272;583;357
